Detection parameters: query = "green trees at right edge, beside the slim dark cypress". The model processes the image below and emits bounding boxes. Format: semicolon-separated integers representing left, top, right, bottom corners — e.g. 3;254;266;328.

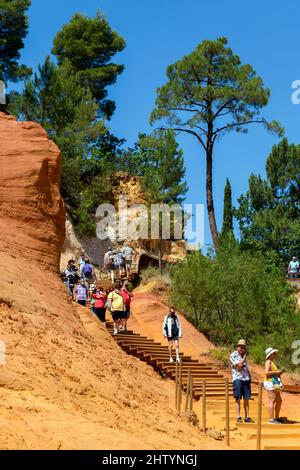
235;139;300;264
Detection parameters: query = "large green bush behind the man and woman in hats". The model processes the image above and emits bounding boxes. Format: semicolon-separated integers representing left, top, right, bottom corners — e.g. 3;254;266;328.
172;240;300;368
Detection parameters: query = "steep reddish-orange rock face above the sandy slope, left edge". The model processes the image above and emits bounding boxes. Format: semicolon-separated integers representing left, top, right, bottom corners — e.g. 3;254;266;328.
0;113;65;271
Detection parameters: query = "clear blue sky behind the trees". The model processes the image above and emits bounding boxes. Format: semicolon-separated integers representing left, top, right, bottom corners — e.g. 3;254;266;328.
10;0;300;248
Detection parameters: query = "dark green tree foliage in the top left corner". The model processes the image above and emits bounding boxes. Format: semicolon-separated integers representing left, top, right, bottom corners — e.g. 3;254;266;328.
0;0;31;82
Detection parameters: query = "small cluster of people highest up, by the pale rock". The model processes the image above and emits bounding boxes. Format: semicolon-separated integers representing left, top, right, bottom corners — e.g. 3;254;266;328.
104;245;134;283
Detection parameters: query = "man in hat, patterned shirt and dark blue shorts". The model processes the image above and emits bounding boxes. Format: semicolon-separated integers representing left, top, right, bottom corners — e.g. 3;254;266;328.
230;339;254;423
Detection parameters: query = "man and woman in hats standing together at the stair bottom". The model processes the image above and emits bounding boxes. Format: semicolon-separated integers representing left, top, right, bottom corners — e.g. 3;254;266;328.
230;339;285;424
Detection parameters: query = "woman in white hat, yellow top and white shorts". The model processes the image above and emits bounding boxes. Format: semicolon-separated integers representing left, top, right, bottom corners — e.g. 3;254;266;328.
264;348;284;424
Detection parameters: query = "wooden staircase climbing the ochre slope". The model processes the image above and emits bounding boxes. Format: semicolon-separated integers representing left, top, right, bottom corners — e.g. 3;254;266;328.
103;322;300;450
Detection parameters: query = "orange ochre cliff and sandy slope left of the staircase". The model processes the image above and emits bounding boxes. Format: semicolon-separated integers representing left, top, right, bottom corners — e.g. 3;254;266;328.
0;115;220;450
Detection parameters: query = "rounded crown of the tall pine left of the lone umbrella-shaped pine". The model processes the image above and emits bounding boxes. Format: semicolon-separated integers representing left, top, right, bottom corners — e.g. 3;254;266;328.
52;12;126;119
